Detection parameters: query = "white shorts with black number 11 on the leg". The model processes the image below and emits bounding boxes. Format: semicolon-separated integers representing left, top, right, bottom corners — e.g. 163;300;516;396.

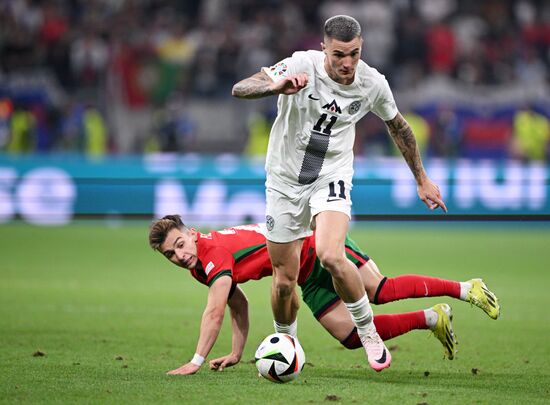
266;176;352;243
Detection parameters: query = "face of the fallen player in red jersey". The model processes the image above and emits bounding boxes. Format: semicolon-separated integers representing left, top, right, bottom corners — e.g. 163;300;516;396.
160;229;198;270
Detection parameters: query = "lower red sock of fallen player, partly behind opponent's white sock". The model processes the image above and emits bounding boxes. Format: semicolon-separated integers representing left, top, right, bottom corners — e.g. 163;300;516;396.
341;311;428;349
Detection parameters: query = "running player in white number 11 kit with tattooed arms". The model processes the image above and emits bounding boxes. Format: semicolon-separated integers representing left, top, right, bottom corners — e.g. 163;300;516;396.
232;16;447;371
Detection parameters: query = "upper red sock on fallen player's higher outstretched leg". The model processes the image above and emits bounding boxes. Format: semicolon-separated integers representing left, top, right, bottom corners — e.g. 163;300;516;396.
373;274;460;304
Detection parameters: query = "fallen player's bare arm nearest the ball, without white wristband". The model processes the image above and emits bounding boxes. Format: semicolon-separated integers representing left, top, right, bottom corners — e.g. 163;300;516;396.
210;286;248;371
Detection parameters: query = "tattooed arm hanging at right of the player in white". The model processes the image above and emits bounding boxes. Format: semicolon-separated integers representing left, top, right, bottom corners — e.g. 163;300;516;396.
385;113;447;212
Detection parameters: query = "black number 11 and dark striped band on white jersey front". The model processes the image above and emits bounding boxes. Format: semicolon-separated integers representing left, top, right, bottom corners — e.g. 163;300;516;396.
298;114;338;184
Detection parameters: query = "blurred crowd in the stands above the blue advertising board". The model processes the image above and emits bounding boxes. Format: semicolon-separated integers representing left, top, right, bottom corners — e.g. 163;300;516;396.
0;0;550;160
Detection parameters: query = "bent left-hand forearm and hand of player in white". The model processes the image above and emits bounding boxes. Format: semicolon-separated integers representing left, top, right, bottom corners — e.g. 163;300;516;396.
231;70;308;98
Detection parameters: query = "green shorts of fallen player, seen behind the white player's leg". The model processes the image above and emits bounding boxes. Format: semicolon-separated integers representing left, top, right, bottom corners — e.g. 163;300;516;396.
300;236;369;319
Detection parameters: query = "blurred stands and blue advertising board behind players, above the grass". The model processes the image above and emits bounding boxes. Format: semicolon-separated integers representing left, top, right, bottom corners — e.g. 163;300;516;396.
0;0;550;225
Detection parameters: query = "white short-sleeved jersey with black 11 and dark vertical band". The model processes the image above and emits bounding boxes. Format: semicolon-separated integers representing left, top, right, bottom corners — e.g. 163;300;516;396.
263;51;397;186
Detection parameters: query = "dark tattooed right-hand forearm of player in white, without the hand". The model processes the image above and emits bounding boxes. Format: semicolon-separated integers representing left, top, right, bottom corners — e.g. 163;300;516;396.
386;113;425;180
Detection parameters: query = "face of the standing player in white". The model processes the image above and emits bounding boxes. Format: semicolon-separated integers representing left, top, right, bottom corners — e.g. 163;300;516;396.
321;37;363;84
